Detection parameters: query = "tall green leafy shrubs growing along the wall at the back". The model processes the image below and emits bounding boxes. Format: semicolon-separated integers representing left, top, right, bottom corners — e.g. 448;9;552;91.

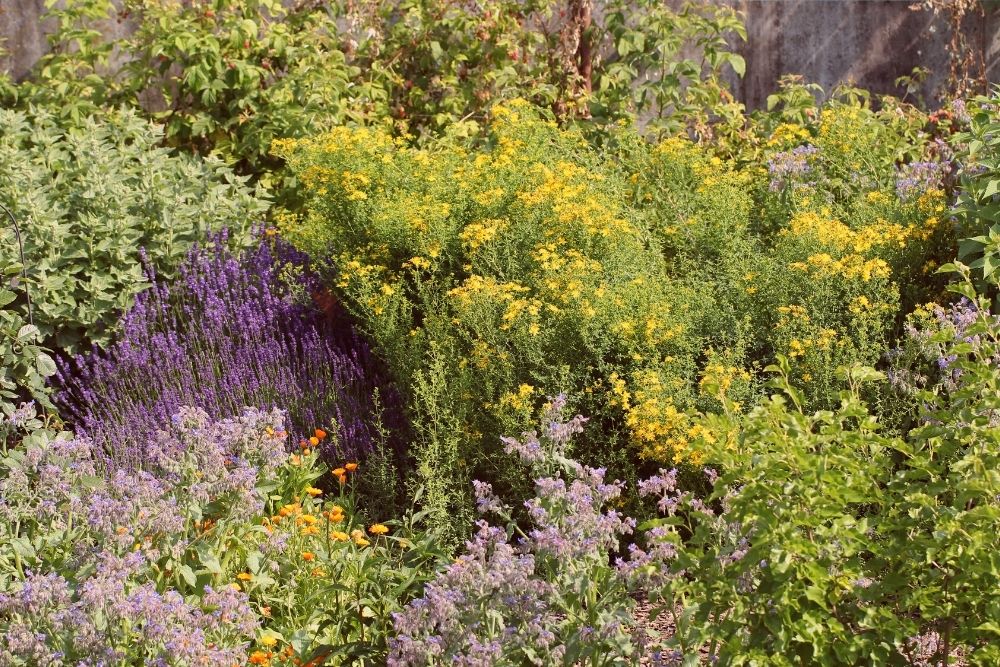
16;0;746;200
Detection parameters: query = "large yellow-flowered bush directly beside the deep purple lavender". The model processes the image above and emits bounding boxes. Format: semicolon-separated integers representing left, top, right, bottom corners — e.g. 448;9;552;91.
281;103;706;532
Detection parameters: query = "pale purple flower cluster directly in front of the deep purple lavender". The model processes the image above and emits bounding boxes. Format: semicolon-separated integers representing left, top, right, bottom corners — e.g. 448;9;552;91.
0;408;285;559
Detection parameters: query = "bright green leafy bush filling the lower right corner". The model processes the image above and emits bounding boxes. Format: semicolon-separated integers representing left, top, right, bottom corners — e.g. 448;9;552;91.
634;270;1000;665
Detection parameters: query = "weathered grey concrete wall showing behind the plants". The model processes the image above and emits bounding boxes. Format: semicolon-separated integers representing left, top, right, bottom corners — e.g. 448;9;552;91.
0;0;1000;108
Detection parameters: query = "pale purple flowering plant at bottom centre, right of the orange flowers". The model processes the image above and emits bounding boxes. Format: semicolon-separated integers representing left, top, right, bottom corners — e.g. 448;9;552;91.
389;397;638;667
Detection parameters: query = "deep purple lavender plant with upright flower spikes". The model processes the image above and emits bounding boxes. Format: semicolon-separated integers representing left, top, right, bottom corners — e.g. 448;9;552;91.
55;241;400;464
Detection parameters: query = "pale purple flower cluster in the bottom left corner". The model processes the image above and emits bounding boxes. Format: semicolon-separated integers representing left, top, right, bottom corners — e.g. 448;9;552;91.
0;552;258;667
